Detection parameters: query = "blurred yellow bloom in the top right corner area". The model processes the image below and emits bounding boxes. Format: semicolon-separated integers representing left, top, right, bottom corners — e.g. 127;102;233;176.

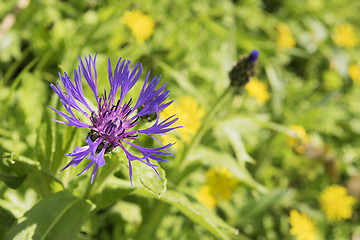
333;23;358;48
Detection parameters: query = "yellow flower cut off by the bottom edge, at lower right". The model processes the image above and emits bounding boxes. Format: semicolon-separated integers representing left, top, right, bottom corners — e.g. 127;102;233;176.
289;210;316;240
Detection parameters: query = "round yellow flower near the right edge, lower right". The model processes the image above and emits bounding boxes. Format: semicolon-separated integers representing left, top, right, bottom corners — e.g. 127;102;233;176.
319;185;355;220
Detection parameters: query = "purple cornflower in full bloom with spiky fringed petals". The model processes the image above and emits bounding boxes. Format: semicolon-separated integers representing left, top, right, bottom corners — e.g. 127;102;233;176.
50;55;178;183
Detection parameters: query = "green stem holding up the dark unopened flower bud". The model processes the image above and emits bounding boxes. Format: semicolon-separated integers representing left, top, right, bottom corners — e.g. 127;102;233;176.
134;87;232;240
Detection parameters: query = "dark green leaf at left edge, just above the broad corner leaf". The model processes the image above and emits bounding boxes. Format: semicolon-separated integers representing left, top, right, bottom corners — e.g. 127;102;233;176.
0;153;63;197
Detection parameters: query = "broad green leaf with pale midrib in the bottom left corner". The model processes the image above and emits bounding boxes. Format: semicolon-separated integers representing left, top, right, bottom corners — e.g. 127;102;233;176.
6;191;93;240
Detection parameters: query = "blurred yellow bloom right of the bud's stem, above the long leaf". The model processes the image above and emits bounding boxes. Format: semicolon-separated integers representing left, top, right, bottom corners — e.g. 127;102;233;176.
196;167;238;209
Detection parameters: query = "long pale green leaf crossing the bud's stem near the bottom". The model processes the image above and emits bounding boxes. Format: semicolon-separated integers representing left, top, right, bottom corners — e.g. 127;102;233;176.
134;189;238;239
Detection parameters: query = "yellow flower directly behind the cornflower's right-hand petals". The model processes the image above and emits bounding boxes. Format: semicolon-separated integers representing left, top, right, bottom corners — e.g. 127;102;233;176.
161;97;205;143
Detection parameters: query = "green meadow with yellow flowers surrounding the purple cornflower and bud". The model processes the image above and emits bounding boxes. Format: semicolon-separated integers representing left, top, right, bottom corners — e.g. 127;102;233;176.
0;0;360;240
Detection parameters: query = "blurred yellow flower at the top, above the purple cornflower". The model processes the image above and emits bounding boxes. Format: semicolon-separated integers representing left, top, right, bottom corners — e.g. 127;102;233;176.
120;10;155;44
